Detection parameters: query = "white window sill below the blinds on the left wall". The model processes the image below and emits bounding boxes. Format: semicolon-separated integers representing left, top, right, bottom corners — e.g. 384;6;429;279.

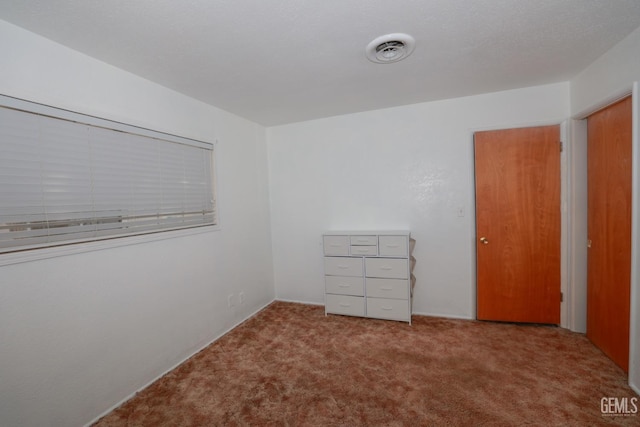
0;225;220;267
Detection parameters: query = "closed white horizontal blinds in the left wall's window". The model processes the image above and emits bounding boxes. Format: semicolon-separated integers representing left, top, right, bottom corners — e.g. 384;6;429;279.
0;96;216;253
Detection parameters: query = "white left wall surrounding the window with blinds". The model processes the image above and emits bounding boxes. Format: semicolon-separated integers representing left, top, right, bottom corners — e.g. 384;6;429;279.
0;21;274;426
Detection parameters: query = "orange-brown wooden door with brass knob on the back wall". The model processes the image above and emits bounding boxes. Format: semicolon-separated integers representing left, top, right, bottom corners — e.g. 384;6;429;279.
475;126;561;324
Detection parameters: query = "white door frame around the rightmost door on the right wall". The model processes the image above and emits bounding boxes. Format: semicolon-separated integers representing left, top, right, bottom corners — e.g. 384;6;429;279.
569;81;640;394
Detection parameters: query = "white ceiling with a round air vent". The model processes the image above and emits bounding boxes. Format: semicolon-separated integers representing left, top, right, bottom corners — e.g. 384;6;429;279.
0;0;640;126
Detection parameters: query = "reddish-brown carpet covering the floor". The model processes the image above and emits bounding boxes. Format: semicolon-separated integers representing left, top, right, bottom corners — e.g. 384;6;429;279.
95;302;640;427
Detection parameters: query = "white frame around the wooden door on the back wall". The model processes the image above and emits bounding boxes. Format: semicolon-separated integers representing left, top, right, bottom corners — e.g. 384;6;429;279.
470;120;572;329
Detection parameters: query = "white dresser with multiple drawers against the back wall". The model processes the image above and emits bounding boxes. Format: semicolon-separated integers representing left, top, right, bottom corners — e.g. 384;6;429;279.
322;231;415;323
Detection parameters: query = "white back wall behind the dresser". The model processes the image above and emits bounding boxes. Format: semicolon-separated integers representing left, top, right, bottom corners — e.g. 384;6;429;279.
267;83;569;318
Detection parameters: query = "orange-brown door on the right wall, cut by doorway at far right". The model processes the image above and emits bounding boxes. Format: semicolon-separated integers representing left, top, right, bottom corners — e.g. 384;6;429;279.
587;97;632;371
